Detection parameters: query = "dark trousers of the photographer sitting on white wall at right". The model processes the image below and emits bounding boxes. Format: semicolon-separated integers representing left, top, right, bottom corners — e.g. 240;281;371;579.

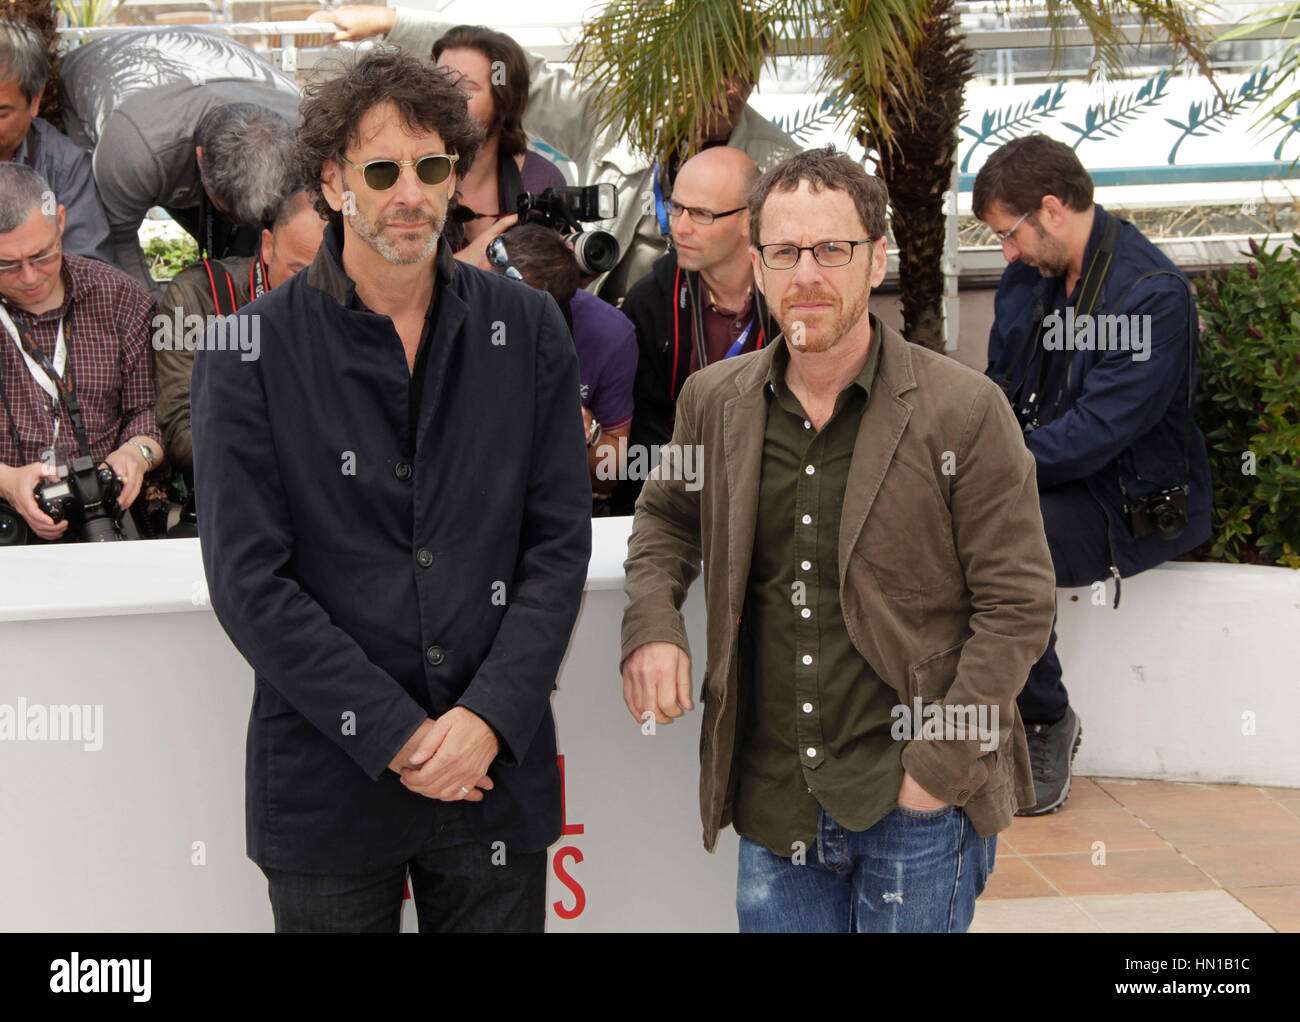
1017;482;1110;724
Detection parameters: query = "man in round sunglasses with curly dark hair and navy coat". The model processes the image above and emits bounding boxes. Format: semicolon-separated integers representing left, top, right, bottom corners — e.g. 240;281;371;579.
192;51;590;931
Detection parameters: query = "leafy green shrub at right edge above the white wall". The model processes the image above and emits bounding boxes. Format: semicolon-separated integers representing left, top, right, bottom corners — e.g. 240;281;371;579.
1196;234;1300;568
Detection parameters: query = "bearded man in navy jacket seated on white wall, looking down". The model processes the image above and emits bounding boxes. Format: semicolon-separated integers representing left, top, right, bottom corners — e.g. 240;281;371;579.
972;134;1212;815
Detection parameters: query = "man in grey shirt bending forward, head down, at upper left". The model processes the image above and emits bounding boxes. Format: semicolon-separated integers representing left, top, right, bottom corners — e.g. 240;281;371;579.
62;27;299;295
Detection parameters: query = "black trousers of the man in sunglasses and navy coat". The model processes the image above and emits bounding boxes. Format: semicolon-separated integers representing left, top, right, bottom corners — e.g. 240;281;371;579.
261;802;546;934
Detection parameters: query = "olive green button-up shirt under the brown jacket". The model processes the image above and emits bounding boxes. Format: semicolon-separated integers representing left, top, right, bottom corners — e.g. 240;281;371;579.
733;316;904;857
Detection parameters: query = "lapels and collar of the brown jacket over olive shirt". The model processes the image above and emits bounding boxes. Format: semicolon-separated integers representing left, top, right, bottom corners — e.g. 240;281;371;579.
723;313;917;620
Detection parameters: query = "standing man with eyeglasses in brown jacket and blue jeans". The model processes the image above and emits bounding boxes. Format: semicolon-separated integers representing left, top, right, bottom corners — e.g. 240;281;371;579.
621;147;1054;932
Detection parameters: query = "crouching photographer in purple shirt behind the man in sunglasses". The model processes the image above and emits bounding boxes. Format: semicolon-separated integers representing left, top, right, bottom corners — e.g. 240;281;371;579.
488;224;637;501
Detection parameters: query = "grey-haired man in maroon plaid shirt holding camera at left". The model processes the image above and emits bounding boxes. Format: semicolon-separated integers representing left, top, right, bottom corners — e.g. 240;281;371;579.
0;164;163;540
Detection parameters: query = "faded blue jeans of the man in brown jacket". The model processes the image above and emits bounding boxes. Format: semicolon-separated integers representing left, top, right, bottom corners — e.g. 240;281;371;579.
736;806;997;934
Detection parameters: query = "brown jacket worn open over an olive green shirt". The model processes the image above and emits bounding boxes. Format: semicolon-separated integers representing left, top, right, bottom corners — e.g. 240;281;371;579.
621;316;1056;852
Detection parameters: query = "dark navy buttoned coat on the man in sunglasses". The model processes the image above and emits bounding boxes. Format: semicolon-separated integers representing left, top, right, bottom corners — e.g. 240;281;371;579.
192;228;592;874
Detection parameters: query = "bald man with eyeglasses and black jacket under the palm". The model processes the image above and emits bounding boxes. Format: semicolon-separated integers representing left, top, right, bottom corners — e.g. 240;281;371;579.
612;146;777;515
